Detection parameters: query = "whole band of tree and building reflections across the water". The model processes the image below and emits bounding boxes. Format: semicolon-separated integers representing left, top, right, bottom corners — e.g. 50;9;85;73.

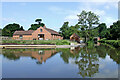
2;46;120;77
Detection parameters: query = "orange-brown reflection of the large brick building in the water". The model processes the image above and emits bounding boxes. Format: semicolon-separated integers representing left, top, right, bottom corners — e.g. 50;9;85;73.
8;50;57;63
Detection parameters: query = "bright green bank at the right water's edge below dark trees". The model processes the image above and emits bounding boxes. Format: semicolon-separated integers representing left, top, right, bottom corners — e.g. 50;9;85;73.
99;39;120;48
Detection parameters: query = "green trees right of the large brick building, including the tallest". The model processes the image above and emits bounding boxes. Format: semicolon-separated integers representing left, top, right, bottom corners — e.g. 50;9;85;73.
60;11;120;42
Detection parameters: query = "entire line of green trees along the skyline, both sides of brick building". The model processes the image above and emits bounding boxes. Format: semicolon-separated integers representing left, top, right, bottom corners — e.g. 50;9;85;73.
2;10;120;42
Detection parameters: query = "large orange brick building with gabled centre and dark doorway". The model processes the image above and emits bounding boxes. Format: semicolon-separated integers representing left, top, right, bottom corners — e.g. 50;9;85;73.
13;26;63;40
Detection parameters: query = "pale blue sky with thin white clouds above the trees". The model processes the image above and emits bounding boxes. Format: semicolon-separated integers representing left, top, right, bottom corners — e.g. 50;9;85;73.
1;0;118;31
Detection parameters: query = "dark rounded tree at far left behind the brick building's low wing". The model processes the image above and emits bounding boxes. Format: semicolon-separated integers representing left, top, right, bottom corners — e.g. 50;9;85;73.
2;23;24;37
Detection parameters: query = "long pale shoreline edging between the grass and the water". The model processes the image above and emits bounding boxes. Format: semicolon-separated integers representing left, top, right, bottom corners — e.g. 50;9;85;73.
0;44;85;49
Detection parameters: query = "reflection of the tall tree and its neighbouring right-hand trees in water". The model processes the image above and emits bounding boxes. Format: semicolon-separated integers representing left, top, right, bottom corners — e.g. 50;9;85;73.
60;45;120;77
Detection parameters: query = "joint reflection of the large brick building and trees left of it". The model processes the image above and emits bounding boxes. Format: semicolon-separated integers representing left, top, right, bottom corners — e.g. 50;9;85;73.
2;49;57;64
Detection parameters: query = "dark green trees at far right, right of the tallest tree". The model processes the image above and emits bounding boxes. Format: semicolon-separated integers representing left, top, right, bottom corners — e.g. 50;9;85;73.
98;20;120;40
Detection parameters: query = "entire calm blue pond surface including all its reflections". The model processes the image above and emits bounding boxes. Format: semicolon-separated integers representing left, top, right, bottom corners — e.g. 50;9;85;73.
0;46;120;78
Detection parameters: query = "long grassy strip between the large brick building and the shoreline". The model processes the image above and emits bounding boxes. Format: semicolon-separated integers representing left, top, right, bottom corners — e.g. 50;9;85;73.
2;40;77;45
